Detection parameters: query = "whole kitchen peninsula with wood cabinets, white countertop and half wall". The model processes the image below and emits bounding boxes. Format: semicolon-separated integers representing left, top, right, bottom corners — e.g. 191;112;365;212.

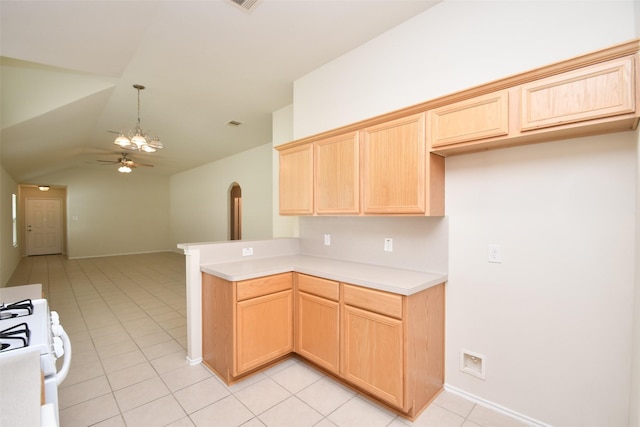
179;239;447;419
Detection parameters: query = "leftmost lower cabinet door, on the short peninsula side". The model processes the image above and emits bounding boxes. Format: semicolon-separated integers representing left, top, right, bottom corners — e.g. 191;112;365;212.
234;290;293;375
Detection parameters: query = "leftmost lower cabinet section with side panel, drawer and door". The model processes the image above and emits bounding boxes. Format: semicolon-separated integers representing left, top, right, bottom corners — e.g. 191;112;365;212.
202;273;293;384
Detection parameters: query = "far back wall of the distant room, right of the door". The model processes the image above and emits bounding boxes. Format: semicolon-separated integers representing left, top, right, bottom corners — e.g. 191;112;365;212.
26;168;171;258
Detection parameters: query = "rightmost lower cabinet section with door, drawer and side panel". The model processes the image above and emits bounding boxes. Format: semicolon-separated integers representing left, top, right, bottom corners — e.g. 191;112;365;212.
341;283;444;419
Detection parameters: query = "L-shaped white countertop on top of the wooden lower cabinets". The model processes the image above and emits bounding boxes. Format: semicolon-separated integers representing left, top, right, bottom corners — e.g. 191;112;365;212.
200;255;447;295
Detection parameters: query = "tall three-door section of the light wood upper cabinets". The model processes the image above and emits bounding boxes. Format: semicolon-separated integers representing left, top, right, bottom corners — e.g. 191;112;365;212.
277;113;444;215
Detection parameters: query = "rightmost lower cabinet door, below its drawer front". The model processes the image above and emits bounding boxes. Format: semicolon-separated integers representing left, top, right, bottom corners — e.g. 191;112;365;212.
342;305;404;408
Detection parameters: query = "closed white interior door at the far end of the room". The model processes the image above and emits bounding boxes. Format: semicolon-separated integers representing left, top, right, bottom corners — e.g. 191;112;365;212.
25;198;62;255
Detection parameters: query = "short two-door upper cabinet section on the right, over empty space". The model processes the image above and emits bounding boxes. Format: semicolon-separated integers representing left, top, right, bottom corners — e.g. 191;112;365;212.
427;41;640;156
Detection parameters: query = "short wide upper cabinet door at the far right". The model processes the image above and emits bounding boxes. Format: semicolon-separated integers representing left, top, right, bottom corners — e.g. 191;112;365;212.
521;57;635;131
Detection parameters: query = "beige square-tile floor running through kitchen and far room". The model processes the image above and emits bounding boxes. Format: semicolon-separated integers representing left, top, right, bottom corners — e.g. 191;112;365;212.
9;252;524;427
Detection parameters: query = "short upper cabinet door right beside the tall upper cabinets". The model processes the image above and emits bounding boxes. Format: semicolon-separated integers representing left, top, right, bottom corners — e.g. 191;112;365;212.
427;90;509;147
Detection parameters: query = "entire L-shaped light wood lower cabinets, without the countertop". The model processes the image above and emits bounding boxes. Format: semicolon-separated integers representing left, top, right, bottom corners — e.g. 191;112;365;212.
202;273;444;419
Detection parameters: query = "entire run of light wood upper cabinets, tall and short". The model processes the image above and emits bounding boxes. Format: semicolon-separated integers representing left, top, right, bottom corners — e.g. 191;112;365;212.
277;40;640;209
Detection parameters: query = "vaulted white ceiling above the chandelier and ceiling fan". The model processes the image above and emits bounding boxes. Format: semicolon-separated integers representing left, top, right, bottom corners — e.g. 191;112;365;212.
0;0;440;183
